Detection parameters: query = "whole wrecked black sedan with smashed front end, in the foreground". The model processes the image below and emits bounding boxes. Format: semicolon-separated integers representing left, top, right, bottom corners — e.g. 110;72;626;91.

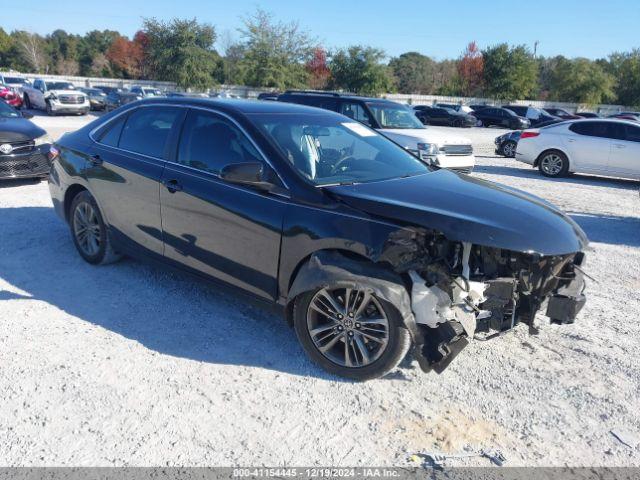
49;98;588;380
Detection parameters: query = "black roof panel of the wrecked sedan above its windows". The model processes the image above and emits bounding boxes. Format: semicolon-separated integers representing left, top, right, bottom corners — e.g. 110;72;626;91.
134;97;340;114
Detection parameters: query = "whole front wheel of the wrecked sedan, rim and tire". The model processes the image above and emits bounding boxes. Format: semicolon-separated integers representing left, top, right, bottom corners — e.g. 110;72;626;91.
293;286;411;381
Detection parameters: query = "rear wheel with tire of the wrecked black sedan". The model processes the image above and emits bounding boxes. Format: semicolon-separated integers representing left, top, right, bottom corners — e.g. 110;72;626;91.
69;190;121;265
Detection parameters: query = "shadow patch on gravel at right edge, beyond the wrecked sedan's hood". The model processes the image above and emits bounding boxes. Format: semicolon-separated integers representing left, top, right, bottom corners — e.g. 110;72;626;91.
569;213;640;247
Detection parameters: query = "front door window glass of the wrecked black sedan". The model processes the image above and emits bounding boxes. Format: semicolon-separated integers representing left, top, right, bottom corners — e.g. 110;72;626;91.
178;110;261;174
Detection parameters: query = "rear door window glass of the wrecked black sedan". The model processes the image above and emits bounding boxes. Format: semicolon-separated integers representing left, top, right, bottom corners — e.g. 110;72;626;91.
118;107;180;158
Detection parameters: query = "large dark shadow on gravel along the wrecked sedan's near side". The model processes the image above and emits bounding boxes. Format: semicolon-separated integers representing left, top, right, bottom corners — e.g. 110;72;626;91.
0;207;376;382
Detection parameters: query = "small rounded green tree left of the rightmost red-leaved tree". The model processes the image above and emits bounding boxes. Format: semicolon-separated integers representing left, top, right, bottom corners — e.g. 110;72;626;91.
389;52;437;95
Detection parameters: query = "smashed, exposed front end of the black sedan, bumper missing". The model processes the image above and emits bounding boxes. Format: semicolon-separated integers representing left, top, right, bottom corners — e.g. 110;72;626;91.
380;229;585;373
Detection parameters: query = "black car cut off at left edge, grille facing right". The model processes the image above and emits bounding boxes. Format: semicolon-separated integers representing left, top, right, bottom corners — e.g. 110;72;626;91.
0;101;55;178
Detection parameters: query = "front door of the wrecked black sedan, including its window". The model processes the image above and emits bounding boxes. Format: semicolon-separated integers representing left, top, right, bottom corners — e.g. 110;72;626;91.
160;109;287;300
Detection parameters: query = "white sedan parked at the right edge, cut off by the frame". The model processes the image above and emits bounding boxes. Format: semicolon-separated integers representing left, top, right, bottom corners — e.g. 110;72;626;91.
516;119;640;179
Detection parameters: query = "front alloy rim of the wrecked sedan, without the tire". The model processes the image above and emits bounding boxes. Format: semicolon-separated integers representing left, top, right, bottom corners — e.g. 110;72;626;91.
307;288;389;368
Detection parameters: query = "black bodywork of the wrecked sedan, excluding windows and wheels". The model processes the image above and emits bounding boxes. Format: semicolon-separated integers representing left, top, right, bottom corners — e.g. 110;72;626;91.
49;98;587;371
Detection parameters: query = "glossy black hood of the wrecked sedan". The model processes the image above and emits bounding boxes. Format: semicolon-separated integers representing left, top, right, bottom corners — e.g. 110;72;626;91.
325;170;588;255
